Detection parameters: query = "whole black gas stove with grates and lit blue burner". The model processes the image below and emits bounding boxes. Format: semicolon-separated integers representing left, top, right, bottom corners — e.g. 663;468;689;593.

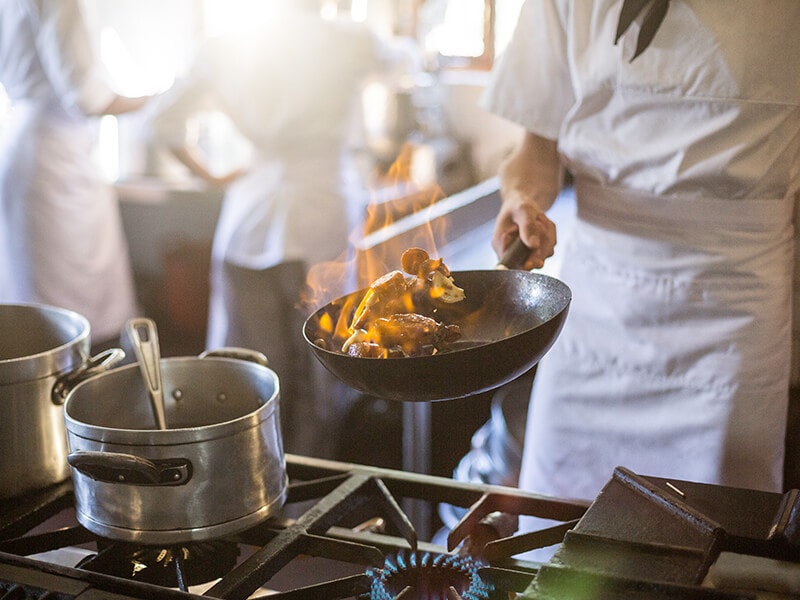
0;455;800;600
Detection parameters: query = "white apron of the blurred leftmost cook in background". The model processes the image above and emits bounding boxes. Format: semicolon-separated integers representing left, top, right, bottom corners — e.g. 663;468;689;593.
0;102;137;343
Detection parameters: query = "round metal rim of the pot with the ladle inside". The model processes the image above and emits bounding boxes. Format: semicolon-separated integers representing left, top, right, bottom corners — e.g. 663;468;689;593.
64;356;280;446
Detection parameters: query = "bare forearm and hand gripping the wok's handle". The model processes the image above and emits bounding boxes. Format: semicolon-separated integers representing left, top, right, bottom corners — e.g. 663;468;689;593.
492;132;563;270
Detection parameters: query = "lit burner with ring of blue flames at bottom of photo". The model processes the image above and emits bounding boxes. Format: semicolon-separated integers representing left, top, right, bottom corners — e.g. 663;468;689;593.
367;552;493;600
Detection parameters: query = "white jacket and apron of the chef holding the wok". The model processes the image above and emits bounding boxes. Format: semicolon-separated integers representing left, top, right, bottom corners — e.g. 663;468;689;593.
484;0;800;499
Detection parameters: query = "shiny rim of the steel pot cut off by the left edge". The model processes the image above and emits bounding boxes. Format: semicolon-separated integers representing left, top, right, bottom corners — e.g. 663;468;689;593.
0;302;91;386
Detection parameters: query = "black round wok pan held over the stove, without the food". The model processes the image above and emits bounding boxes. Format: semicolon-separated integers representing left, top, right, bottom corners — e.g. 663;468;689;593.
303;270;572;402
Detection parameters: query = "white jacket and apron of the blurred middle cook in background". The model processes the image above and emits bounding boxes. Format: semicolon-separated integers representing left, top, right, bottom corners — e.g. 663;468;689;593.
148;7;384;348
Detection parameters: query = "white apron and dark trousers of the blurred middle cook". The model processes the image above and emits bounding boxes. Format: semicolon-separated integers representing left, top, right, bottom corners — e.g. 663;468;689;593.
206;148;362;456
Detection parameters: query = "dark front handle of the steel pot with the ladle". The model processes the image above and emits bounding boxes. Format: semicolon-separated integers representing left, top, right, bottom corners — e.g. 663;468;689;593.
67;450;192;486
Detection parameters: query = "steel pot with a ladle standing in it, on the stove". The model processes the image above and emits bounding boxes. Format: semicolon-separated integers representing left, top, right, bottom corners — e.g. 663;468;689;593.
65;354;288;544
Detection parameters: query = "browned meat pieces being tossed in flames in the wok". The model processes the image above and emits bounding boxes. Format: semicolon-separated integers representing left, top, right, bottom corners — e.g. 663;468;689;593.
341;248;465;358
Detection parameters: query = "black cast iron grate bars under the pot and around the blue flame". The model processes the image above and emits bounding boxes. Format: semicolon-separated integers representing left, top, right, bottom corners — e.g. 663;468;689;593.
0;455;587;600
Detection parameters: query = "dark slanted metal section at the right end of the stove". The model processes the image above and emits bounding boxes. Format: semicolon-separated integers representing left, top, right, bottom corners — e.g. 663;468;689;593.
526;467;800;600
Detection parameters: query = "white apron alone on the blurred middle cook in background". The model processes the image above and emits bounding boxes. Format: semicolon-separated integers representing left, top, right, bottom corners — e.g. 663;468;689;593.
206;148;365;349
